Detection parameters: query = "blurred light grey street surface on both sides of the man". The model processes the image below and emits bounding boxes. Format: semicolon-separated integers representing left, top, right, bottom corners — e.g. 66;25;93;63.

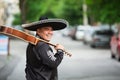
0;33;120;80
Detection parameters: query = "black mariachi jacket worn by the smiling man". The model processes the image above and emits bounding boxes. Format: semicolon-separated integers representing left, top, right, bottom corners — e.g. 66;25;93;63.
25;42;63;80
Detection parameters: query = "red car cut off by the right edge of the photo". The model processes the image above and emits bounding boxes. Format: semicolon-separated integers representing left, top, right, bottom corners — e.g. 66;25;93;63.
110;31;120;61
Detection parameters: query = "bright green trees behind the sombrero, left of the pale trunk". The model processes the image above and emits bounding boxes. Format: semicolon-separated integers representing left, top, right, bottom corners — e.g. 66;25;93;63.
13;0;83;25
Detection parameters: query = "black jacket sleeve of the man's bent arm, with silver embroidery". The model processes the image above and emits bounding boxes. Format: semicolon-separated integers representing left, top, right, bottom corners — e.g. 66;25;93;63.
36;42;63;68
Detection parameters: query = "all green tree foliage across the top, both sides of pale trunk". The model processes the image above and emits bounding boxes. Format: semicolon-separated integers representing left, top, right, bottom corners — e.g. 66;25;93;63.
13;0;120;25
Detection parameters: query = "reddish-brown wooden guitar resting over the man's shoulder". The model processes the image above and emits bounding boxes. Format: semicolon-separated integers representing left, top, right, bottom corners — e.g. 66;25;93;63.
0;26;72;57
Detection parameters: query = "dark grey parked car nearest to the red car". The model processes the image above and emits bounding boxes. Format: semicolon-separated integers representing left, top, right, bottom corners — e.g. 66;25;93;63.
90;29;114;48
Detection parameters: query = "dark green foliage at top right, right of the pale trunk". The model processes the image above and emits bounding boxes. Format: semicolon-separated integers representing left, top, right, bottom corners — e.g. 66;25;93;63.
87;0;120;25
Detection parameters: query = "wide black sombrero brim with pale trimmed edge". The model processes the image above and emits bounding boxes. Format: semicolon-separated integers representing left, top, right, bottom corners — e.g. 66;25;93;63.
22;19;68;31
